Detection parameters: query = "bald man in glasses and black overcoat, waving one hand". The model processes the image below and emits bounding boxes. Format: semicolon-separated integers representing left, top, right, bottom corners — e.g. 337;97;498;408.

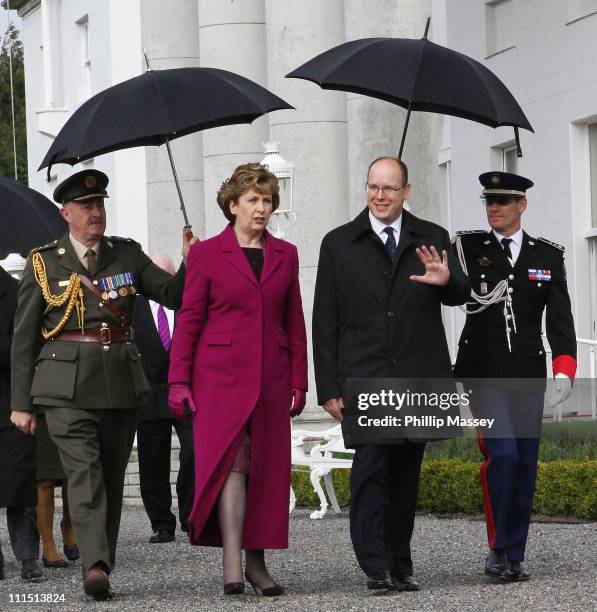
313;157;470;593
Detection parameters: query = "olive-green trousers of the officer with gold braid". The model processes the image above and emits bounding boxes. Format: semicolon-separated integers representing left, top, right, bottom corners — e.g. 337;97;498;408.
45;407;137;570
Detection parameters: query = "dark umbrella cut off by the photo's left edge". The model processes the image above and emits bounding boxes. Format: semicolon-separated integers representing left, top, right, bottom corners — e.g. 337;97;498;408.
0;177;68;259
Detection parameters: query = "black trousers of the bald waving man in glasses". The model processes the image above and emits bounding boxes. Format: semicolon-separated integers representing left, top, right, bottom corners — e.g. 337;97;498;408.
350;442;425;577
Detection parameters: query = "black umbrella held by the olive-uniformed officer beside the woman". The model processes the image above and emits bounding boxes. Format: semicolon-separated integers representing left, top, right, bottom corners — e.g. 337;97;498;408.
38;62;293;225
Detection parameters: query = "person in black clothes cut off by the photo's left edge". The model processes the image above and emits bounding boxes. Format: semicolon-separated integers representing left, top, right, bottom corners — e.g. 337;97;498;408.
0;267;42;580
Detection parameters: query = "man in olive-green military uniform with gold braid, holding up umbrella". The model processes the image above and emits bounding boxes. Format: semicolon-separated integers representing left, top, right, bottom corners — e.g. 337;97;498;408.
11;170;194;599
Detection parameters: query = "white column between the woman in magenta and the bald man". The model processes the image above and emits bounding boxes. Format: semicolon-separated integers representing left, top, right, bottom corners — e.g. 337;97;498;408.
266;0;349;421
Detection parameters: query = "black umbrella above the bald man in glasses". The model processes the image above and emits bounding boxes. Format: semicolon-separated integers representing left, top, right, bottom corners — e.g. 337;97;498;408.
286;20;533;157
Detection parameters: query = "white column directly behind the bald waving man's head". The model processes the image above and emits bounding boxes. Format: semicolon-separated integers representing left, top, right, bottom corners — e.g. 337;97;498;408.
345;0;440;222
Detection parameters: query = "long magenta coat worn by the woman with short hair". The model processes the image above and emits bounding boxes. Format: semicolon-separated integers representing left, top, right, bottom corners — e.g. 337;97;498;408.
169;225;307;549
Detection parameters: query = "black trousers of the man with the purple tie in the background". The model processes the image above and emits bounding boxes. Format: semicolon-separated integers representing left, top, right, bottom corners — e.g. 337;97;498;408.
137;419;195;531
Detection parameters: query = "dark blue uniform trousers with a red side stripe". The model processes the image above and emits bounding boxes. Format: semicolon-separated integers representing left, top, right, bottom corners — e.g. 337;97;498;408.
471;385;544;561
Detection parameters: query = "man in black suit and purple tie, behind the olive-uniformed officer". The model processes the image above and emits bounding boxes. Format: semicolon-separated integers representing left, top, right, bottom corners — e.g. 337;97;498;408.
133;255;195;544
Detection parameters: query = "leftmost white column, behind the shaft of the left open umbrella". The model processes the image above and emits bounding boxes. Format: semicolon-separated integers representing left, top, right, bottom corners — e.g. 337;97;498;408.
141;0;205;262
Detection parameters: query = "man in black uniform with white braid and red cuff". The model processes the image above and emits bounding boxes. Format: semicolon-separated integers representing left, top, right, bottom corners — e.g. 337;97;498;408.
455;172;576;582
